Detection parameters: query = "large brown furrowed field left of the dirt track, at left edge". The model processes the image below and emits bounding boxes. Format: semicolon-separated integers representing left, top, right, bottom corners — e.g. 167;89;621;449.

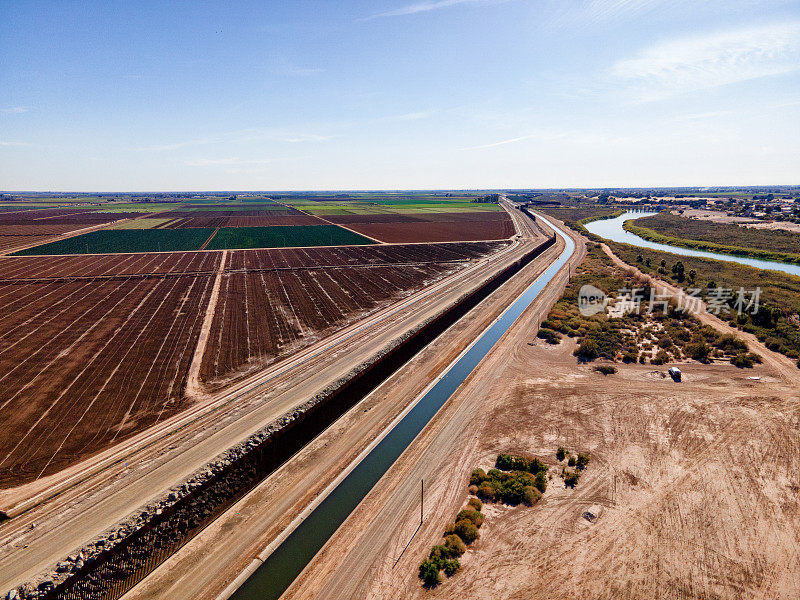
0;259;219;485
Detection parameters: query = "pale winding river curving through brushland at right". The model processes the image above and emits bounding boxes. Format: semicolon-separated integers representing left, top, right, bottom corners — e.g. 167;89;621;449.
584;211;800;276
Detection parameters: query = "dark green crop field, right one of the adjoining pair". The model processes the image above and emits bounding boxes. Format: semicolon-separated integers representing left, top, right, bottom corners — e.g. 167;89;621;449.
203;225;374;250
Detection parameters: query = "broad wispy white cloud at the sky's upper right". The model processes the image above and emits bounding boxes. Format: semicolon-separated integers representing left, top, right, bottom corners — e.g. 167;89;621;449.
610;22;800;101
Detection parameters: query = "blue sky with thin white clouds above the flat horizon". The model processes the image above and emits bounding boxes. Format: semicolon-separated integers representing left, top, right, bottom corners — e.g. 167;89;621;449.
0;0;800;192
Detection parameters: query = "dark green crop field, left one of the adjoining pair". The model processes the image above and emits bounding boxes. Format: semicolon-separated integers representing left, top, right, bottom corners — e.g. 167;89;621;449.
14;228;214;256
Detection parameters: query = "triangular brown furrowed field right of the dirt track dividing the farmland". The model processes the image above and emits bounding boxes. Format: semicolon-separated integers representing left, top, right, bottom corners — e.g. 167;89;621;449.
200;243;502;383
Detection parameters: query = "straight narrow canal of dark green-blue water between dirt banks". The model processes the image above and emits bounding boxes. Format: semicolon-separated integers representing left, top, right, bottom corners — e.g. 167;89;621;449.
232;217;575;600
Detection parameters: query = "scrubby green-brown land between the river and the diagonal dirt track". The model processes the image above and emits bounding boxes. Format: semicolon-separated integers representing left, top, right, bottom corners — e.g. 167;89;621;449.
608;242;800;367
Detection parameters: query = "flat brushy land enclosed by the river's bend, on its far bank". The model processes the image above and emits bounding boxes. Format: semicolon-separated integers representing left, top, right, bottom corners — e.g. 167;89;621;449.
623;211;800;263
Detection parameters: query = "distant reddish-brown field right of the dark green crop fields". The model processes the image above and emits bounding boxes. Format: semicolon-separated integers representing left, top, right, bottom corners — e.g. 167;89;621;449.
328;211;514;243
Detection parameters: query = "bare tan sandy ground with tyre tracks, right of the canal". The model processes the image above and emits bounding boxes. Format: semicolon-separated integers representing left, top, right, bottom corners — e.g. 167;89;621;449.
286;226;800;599
